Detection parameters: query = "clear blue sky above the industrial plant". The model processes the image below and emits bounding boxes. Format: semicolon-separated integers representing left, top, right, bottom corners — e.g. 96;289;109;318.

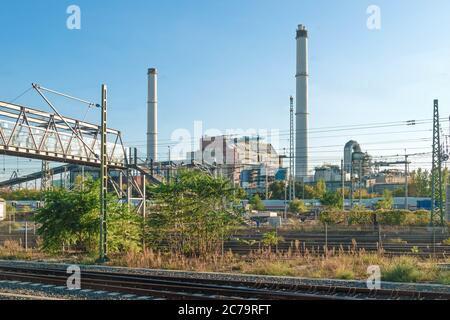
0;0;450;176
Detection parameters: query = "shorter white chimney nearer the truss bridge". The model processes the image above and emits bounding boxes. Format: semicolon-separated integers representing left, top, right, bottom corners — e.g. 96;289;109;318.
147;68;158;162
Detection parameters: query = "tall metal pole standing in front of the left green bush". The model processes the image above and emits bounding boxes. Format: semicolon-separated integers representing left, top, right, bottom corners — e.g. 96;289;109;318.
100;84;108;261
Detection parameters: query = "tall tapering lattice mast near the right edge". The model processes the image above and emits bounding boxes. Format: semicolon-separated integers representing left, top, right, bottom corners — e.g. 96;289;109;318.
431;100;444;225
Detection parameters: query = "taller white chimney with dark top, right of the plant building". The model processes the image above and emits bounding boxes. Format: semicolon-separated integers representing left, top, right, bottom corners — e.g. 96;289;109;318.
295;25;309;180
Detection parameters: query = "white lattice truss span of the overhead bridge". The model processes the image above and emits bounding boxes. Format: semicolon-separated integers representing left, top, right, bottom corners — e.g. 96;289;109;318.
0;101;127;168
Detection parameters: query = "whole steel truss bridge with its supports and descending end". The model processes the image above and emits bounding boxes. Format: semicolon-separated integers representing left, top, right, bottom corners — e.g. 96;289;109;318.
0;84;152;215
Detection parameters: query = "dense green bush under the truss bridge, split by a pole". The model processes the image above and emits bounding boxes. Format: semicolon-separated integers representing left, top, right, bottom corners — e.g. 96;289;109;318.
35;179;141;253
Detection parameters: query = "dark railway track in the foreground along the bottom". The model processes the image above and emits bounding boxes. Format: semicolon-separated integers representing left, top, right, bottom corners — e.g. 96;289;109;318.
0;265;450;300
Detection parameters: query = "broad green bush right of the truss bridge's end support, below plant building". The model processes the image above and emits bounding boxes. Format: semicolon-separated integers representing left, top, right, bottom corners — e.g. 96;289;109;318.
147;170;242;255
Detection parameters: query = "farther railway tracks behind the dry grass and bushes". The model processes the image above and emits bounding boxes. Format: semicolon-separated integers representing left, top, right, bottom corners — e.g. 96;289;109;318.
0;230;450;258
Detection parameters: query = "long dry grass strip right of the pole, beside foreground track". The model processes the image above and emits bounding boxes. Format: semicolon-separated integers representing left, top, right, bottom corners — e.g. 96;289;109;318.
111;248;450;284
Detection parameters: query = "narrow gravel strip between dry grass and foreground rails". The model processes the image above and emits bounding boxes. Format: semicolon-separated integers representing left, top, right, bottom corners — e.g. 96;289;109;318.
0;260;450;293
